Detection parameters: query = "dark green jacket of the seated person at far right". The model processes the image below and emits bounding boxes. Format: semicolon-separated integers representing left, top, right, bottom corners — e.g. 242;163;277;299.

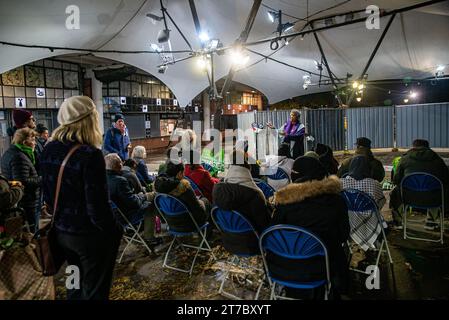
393;147;449;186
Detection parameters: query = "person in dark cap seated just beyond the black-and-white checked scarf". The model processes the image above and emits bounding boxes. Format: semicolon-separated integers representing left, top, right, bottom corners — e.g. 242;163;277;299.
337;137;385;182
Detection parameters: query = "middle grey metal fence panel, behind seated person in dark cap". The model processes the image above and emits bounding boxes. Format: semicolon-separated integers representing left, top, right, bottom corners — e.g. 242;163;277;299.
347;107;394;149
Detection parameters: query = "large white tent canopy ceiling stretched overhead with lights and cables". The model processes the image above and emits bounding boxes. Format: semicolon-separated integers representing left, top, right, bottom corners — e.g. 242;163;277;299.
0;0;449;105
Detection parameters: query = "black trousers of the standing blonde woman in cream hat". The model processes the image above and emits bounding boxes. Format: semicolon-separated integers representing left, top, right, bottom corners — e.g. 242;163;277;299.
56;231;121;300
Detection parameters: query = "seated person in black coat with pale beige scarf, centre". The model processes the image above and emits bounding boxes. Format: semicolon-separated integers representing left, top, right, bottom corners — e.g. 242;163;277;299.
212;151;271;234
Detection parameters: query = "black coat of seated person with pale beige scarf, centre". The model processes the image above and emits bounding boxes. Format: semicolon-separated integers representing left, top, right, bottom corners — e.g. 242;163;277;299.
212;182;271;234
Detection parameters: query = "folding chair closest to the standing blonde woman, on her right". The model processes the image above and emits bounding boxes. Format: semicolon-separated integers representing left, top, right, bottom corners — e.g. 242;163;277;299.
110;201;154;263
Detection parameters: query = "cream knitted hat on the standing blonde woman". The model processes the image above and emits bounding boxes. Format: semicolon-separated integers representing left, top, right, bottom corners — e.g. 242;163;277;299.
58;96;95;125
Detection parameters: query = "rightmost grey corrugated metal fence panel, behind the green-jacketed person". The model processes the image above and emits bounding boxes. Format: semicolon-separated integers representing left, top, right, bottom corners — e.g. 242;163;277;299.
396;102;449;148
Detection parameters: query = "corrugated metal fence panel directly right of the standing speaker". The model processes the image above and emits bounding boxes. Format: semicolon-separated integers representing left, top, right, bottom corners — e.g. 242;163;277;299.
306;109;345;150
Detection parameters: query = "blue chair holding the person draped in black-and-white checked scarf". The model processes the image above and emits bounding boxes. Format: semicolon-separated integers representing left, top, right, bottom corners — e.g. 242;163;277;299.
341;188;393;274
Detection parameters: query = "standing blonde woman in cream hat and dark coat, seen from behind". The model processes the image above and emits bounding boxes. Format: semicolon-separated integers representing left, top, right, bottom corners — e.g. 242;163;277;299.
41;96;120;300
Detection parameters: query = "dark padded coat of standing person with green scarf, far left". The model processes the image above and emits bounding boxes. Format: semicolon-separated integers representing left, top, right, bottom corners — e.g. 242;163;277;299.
2;145;41;221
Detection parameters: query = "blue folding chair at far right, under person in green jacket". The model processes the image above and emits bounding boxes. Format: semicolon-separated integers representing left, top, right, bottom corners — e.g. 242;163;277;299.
400;172;445;244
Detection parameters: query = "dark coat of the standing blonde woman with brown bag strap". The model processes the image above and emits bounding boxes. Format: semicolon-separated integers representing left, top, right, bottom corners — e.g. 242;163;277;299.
41;141;117;235
